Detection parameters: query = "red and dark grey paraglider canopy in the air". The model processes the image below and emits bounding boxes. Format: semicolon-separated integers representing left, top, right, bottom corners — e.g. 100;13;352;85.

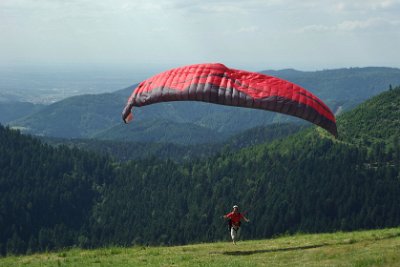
122;63;337;137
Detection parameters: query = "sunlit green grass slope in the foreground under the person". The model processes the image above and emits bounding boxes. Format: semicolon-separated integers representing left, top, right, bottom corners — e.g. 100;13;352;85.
0;228;400;267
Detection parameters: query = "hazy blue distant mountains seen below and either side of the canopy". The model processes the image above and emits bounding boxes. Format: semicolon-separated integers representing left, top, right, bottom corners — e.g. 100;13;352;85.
0;67;400;144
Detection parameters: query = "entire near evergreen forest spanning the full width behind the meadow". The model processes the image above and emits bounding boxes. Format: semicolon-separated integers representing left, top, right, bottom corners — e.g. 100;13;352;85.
0;88;400;255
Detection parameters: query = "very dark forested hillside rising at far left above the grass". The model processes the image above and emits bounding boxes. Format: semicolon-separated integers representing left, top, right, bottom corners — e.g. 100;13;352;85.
0;126;113;254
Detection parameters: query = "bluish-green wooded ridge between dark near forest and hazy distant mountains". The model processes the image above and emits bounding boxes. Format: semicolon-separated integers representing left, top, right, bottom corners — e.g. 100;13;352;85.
42;124;305;162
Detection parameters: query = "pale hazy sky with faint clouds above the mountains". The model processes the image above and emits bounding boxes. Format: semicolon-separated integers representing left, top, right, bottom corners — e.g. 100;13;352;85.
0;0;400;71
